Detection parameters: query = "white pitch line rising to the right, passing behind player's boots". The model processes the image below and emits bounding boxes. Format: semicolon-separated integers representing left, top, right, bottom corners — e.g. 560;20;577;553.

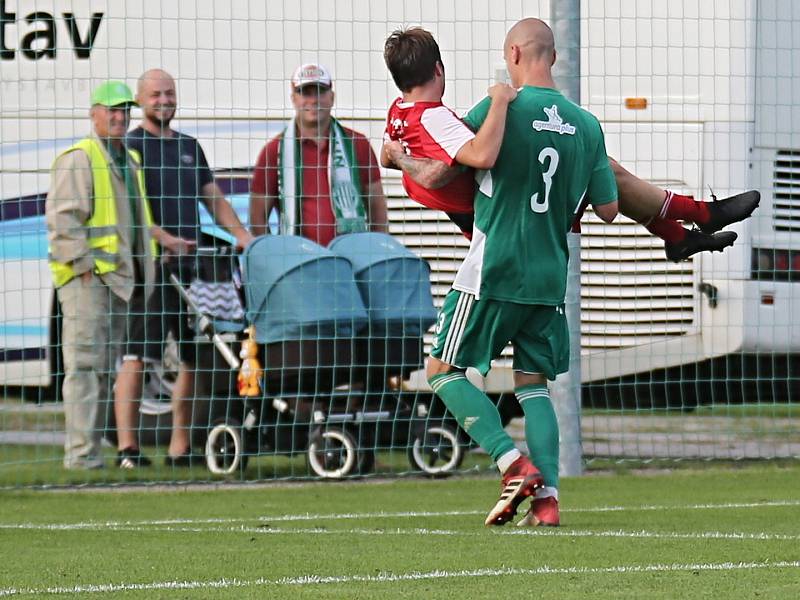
0;500;800;531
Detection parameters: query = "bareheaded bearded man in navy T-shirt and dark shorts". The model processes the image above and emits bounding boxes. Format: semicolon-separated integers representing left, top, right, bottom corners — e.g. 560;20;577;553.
114;69;252;469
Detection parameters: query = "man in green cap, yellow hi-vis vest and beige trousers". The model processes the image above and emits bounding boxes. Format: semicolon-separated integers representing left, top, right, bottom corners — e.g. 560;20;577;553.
46;81;184;469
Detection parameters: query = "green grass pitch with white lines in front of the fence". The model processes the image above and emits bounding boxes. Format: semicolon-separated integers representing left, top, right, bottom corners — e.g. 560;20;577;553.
0;462;800;600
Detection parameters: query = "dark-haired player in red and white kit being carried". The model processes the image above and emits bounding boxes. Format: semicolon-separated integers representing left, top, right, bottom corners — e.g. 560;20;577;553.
381;27;760;262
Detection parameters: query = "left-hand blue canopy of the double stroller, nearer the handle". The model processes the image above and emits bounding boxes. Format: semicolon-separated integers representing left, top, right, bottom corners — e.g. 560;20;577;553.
242;235;367;344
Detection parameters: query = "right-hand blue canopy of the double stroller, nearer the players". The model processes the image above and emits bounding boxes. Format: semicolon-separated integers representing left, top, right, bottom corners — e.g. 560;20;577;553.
329;233;436;336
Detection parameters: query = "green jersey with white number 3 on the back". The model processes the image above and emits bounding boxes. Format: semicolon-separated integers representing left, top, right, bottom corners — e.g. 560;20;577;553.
453;87;617;305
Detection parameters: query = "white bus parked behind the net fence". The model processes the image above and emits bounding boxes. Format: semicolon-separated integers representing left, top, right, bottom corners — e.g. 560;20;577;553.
0;0;800;406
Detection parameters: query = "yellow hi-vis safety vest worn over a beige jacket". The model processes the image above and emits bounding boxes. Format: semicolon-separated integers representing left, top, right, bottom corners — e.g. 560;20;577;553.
50;138;158;287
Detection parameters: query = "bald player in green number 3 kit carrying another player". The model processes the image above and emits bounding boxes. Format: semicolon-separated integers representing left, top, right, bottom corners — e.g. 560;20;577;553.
427;18;617;526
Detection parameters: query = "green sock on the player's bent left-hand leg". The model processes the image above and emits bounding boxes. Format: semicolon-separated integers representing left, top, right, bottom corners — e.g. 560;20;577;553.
428;371;516;462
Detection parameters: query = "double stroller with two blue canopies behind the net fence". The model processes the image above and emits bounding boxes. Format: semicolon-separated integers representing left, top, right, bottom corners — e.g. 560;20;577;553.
193;233;468;479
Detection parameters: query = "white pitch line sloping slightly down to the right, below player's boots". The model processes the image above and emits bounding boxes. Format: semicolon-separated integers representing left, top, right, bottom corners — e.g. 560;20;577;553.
6;524;800;541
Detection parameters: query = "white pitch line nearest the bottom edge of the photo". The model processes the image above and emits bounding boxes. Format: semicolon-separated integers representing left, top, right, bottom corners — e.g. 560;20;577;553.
0;561;800;597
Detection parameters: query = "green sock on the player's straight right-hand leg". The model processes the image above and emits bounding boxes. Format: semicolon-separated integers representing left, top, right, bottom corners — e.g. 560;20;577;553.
514;384;558;488
